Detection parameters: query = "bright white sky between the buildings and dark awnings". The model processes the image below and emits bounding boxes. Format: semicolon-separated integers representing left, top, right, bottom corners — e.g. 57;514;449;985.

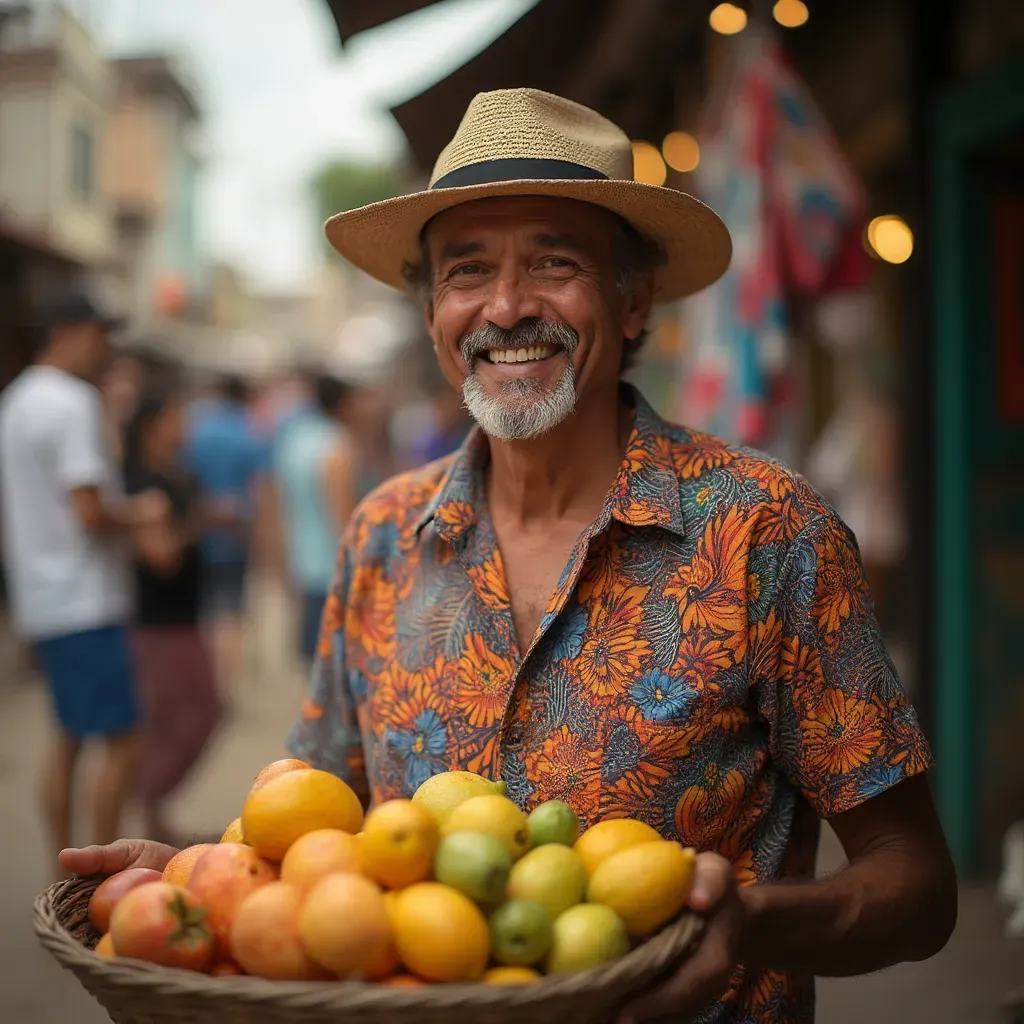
65;0;537;291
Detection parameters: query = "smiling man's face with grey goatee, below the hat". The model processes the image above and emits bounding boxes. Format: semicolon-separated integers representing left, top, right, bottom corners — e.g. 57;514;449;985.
426;196;650;440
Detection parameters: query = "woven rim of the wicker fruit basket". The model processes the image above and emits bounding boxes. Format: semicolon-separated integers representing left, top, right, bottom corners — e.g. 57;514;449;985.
33;876;703;1012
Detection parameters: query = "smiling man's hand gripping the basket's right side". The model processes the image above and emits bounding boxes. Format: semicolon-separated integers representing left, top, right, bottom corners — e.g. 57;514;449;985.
618;853;743;1024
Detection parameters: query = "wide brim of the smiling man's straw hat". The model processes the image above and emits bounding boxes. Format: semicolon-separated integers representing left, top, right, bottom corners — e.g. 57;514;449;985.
325;178;732;302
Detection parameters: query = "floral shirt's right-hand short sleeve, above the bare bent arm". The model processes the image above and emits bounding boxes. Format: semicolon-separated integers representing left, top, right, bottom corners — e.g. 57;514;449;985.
751;512;933;818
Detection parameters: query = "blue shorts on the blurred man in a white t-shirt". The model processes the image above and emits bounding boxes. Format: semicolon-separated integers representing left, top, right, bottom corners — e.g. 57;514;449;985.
36;626;139;739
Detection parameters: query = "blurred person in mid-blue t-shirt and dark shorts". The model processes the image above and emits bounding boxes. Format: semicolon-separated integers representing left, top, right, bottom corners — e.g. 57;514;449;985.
188;376;273;688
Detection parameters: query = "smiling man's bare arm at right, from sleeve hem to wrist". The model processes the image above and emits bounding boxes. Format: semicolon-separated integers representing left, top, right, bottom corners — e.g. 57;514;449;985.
737;775;956;977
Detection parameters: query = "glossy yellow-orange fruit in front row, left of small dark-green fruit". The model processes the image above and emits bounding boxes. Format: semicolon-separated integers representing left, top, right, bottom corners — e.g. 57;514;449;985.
392;882;490;981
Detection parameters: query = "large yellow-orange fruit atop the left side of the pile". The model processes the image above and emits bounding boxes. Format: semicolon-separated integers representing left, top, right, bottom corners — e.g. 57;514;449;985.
242;768;362;861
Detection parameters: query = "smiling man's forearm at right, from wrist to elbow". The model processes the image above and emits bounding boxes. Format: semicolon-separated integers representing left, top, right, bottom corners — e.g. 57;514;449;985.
738;850;956;977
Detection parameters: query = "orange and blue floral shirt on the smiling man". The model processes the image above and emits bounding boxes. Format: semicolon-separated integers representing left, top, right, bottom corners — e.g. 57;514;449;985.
291;390;931;1024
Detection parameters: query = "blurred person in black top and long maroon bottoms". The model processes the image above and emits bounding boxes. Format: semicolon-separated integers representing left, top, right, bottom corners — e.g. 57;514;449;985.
125;381;221;843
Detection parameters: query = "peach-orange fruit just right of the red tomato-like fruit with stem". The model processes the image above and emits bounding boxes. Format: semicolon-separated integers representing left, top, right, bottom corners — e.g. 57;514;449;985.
229;882;327;981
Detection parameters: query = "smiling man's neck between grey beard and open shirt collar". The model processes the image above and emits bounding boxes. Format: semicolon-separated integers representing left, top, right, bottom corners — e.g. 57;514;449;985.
487;388;630;526
